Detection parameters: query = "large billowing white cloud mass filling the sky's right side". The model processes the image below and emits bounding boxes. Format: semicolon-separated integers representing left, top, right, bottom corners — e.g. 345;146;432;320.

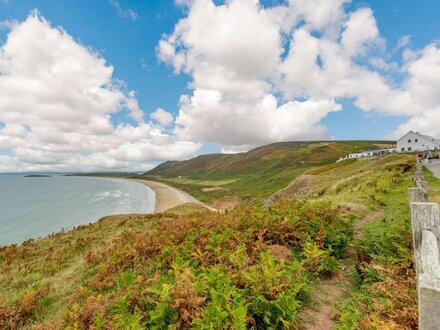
158;0;440;148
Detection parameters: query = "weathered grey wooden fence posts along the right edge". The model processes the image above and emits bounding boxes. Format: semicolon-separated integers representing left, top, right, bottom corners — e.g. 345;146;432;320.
408;158;440;330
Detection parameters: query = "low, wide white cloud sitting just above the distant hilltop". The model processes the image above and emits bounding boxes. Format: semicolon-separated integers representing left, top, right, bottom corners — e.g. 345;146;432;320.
176;89;341;149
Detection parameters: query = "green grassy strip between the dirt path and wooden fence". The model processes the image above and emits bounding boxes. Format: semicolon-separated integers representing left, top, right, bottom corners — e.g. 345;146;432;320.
283;155;418;329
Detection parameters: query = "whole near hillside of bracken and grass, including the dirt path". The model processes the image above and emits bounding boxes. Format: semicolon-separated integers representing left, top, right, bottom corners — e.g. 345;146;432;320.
0;155;424;329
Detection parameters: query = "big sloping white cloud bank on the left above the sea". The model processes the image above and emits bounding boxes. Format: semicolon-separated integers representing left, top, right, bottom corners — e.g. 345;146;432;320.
0;13;200;171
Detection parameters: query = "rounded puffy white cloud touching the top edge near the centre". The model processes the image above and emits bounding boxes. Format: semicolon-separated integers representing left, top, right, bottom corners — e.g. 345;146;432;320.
159;0;282;84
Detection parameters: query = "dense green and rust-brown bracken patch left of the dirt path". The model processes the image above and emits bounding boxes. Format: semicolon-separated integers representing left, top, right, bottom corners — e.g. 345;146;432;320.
49;200;350;329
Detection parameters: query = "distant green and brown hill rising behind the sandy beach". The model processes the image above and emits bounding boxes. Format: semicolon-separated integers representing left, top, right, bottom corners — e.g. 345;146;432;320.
142;141;393;207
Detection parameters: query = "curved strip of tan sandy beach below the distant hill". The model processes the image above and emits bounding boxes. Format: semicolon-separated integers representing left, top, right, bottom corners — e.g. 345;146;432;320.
128;179;217;213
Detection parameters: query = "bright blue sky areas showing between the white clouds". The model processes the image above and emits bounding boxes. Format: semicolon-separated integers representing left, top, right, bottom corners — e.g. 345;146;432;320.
0;0;440;167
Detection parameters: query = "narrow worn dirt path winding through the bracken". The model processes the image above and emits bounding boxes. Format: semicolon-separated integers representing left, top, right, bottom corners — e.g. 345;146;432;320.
301;210;383;330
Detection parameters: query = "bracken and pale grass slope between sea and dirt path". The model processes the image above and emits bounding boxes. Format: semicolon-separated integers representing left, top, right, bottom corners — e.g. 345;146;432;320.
0;200;351;329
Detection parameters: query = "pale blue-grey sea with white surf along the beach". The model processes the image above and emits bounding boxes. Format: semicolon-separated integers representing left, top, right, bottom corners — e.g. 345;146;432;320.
0;175;155;246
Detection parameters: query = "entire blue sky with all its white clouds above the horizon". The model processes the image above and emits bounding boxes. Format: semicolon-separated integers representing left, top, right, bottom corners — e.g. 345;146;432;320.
0;0;440;172
